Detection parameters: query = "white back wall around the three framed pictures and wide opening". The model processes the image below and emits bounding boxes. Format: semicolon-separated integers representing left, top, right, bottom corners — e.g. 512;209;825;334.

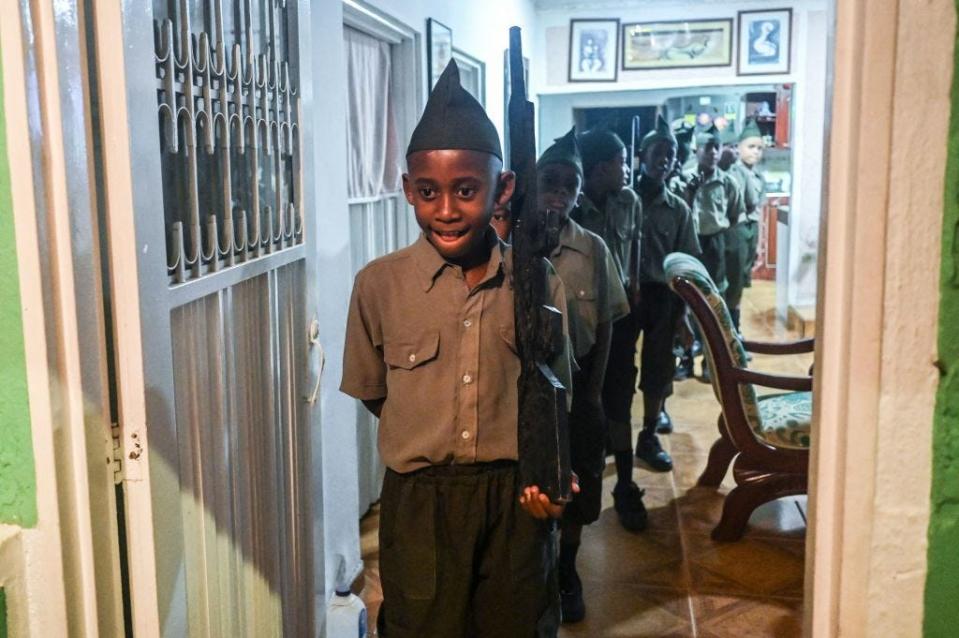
530;0;829;316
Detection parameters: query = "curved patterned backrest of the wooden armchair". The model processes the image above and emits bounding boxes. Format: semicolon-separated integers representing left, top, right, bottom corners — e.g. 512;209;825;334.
663;253;762;434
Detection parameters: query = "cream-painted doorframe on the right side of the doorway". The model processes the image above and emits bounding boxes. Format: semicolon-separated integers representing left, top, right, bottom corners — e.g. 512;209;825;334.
805;0;956;637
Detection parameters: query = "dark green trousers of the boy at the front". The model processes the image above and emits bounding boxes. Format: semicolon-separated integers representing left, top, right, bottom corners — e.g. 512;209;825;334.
380;461;559;638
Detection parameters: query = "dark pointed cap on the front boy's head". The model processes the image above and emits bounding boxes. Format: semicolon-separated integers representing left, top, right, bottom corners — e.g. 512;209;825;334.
406;60;503;160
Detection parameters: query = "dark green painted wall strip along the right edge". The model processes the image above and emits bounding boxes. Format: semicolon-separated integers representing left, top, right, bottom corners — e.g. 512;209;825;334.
924;6;959;638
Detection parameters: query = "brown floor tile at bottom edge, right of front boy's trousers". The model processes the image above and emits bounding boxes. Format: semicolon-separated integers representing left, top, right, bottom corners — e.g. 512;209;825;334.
559;582;693;638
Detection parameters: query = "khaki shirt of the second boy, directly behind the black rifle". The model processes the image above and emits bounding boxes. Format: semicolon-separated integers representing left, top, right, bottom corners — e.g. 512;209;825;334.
549;220;629;359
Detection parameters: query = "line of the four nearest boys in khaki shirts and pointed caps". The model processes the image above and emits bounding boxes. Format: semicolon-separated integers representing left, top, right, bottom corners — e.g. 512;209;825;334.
341;62;760;638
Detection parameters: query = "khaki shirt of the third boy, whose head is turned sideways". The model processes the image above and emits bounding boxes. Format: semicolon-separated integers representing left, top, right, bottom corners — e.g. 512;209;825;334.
570;188;643;288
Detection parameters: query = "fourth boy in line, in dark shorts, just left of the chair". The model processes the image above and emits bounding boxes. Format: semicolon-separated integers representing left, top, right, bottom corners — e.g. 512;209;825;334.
636;116;699;458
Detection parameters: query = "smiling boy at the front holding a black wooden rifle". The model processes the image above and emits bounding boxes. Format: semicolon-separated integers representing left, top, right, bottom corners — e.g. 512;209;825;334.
341;62;576;638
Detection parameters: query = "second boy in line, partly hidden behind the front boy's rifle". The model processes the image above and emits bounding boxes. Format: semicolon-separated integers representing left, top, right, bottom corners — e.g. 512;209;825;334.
536;130;629;622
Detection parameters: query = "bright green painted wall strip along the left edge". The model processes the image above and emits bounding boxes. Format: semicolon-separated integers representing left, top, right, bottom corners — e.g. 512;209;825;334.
0;53;37;528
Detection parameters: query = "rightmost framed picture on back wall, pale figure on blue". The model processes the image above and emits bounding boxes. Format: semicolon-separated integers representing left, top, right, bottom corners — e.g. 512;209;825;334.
736;9;792;75
